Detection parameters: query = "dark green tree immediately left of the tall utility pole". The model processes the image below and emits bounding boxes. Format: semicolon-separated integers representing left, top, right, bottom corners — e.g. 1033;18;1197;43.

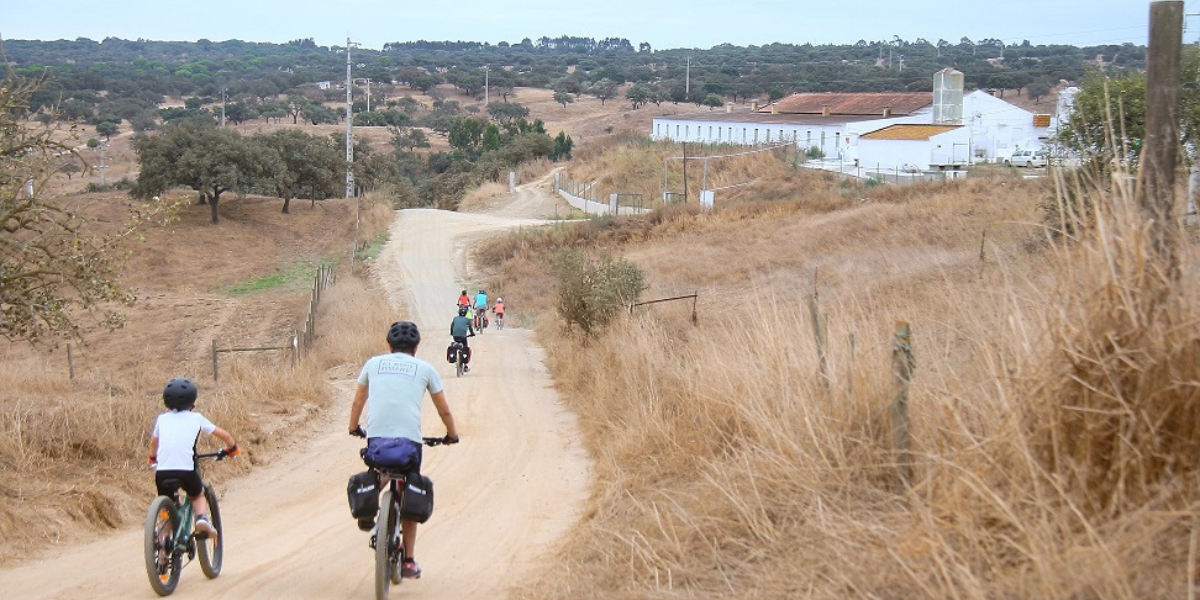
254;130;341;214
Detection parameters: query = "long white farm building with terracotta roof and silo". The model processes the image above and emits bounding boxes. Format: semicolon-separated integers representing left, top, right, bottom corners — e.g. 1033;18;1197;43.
650;68;1051;175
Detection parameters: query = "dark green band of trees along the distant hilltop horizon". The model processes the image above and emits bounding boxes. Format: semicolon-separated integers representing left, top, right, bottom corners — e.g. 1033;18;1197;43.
4;36;1145;136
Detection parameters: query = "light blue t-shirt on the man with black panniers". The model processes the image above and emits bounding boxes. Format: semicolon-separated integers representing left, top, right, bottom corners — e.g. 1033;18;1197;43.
359;352;442;443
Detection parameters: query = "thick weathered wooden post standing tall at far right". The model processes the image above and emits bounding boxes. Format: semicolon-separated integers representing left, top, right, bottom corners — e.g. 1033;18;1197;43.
1138;0;1183;280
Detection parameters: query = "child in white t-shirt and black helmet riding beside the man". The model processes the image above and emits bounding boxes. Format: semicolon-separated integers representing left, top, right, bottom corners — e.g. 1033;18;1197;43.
150;377;241;534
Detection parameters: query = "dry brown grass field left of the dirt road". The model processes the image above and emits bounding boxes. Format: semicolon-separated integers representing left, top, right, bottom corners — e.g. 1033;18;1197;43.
0;192;394;564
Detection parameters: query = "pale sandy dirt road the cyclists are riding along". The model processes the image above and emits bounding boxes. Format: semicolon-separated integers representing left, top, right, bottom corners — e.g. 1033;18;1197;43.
0;181;589;599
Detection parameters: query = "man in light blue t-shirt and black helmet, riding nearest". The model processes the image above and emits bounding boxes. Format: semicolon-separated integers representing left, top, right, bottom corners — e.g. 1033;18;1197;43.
349;320;458;578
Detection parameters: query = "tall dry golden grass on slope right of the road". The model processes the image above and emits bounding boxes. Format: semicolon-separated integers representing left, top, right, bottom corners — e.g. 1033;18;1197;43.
506;166;1200;599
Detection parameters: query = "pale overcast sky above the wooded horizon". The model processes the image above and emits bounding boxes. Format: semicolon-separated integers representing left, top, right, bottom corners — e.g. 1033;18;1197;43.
0;0;1161;49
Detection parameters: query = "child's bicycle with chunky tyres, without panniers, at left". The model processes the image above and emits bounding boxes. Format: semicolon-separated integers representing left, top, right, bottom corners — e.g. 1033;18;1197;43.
145;449;229;596
